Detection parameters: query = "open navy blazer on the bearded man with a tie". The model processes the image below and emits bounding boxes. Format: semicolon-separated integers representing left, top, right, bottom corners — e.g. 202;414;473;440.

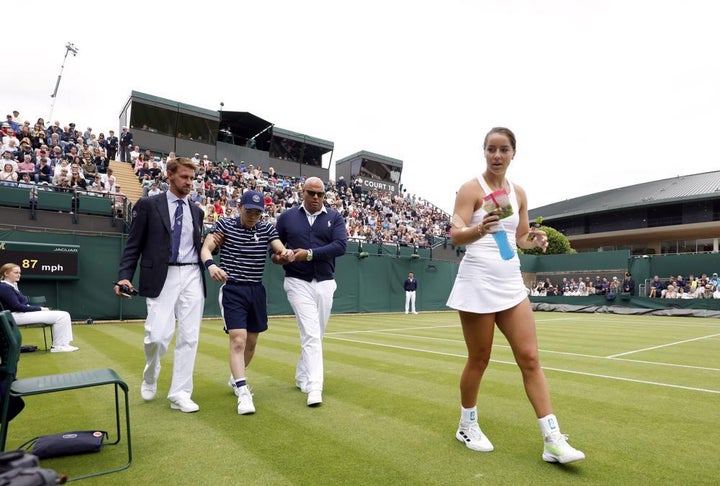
118;192;207;298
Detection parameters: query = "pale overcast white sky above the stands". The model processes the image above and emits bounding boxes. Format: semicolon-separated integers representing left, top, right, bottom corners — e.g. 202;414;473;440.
0;0;720;211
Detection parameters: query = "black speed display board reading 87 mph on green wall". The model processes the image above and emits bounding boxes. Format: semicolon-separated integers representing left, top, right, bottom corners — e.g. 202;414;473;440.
0;241;80;280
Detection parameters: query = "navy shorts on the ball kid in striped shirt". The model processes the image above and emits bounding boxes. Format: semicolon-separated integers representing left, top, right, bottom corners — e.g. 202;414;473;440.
220;282;268;332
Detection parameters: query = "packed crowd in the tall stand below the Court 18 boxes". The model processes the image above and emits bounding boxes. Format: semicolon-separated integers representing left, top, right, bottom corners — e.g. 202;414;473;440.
0;111;450;247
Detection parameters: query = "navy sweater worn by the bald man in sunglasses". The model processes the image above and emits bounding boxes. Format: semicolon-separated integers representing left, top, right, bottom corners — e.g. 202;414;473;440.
277;207;347;282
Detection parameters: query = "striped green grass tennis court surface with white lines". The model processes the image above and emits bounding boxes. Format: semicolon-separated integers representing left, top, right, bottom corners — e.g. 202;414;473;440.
8;312;720;485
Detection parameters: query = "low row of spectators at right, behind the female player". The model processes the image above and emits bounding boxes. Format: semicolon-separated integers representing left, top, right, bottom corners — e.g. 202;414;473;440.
530;273;720;299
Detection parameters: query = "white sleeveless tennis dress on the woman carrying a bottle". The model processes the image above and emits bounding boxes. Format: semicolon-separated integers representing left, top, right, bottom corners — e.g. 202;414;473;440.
446;176;527;314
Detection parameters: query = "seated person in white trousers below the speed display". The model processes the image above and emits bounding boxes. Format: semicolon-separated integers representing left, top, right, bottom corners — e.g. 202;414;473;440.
0;263;78;353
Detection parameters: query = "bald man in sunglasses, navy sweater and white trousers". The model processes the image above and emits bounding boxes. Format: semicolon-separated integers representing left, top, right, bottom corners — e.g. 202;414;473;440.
272;177;347;407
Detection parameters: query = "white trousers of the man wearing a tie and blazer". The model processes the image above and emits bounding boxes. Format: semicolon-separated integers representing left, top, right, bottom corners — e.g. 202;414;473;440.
143;265;205;399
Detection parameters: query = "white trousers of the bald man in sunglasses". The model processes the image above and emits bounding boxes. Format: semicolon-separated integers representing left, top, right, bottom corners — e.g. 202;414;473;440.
283;277;337;393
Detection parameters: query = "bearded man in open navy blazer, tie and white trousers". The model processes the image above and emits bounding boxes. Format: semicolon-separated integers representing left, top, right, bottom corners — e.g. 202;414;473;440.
114;157;206;412
